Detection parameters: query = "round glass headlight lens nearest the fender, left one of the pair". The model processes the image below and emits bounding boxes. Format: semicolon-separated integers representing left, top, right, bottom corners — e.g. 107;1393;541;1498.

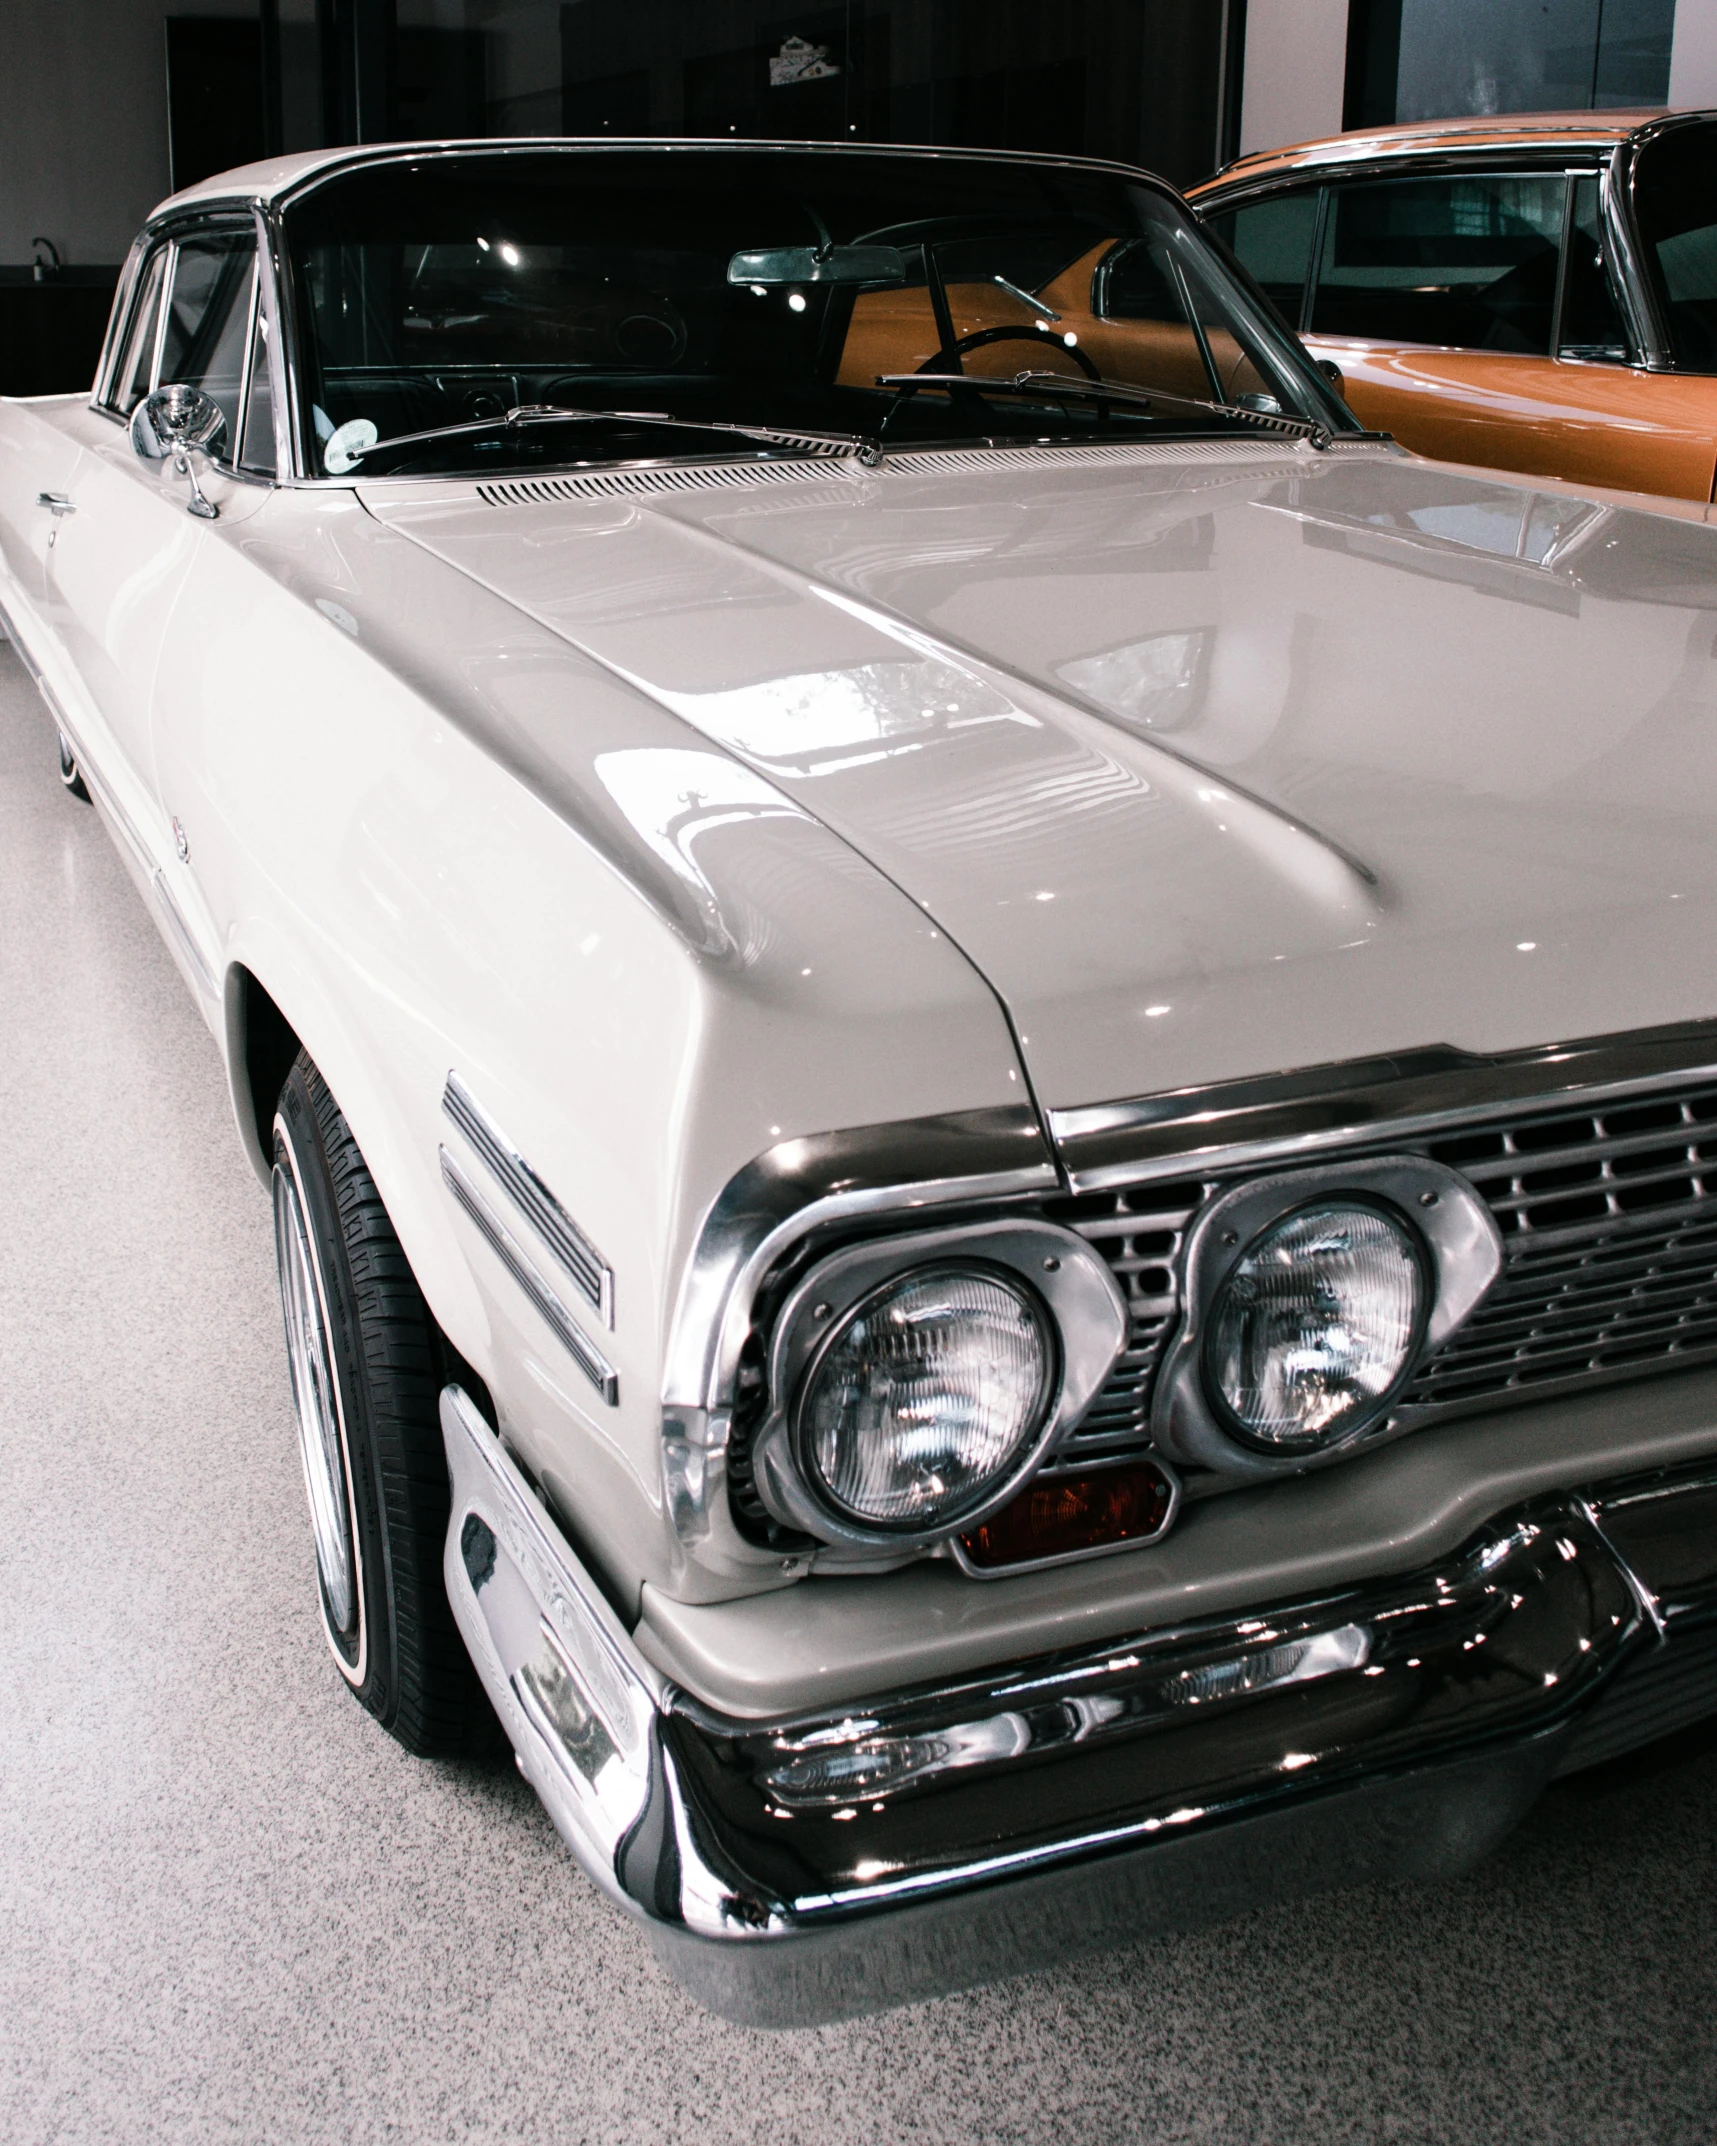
794;1266;1056;1532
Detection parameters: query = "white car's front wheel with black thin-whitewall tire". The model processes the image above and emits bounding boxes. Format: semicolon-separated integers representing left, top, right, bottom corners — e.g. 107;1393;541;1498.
275;1052;494;1755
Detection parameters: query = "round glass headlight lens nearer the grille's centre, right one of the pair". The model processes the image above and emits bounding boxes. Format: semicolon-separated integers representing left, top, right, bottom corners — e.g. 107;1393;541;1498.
1204;1206;1427;1453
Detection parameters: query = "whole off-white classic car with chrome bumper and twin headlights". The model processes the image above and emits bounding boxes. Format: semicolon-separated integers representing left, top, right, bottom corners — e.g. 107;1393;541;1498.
0;142;1717;2022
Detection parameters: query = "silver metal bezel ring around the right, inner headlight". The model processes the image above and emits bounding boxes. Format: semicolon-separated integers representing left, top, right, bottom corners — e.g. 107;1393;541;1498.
1150;1155;1502;1481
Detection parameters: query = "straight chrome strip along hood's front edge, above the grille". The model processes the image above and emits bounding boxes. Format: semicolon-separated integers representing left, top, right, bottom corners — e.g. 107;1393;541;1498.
1050;1019;1717;1193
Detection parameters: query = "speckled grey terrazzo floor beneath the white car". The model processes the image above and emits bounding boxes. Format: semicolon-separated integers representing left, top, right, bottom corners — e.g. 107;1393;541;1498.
0;646;1717;2146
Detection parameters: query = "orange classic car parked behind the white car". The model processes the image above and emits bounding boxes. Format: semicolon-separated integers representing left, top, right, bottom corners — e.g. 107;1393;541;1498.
1189;112;1717;500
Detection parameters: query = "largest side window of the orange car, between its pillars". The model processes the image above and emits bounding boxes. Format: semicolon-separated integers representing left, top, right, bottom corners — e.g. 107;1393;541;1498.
1311;172;1567;356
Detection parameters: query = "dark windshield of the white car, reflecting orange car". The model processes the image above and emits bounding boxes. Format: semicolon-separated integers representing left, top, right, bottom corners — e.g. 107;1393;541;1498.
285;148;1352;476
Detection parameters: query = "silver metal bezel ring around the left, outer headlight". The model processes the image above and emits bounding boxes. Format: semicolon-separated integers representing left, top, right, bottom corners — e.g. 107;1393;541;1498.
751;1217;1129;1556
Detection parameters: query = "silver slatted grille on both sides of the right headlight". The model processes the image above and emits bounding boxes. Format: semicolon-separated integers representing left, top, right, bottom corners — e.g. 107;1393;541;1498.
1073;1086;1717;1457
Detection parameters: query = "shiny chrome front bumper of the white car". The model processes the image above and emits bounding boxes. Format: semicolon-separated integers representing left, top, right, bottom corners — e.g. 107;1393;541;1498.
442;1386;1717;2026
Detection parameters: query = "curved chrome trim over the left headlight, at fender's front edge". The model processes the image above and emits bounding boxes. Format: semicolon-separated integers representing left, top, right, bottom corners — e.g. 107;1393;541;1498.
661;1103;1060;1444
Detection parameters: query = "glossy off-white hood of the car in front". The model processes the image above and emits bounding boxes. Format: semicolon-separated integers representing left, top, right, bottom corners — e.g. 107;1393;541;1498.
367;442;1717;1109
